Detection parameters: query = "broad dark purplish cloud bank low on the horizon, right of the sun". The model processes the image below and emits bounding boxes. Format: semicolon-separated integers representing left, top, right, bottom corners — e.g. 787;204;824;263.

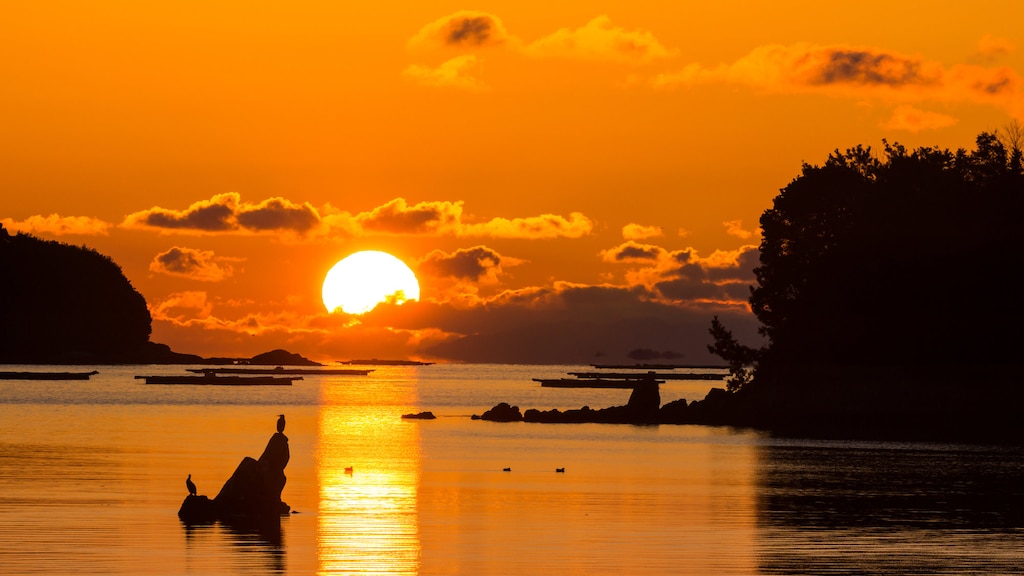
369;283;759;364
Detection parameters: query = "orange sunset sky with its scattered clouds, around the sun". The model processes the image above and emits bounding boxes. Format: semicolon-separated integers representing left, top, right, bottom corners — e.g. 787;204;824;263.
0;0;1024;364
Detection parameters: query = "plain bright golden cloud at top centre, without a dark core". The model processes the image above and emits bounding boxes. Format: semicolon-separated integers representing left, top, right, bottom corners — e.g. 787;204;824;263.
522;14;676;64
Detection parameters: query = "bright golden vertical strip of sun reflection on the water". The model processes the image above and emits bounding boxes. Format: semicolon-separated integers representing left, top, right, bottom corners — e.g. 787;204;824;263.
316;375;420;574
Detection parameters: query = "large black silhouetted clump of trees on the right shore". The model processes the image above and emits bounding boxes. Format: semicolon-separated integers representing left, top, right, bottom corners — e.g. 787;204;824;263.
710;133;1024;434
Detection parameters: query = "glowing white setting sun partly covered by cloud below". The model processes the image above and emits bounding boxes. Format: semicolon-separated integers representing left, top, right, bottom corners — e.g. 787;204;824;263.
324;250;420;314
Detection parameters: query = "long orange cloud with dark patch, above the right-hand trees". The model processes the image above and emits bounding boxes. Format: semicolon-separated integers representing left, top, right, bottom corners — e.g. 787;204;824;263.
652;43;1024;114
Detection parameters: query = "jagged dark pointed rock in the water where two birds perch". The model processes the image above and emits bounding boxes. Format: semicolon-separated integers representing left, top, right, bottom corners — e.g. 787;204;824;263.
178;433;291;523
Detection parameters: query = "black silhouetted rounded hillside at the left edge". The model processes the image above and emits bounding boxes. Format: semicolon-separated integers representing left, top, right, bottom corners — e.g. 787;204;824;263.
0;227;198;364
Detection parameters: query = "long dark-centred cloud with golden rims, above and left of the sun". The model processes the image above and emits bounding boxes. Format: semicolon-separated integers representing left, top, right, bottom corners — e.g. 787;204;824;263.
121;192;319;235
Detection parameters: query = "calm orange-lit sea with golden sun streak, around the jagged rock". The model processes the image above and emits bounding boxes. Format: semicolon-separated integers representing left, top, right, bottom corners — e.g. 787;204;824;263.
0;364;1024;576
